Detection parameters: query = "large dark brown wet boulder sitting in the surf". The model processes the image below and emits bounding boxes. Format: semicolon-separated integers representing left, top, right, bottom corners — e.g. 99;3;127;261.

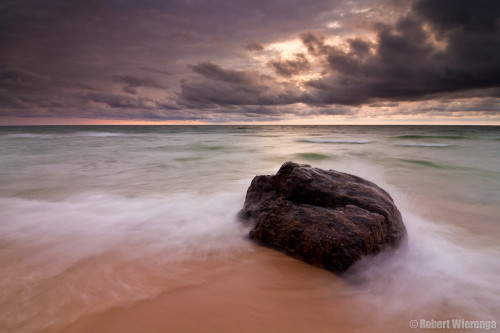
240;162;406;272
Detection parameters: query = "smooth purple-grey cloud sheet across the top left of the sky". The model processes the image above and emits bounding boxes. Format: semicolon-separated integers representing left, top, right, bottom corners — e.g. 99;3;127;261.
0;0;336;73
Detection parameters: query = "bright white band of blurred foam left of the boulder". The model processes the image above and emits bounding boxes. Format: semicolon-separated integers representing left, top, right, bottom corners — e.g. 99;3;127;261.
0;193;249;260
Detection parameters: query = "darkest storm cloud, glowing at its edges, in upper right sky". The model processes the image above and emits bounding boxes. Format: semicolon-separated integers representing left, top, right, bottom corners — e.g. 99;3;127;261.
292;0;500;105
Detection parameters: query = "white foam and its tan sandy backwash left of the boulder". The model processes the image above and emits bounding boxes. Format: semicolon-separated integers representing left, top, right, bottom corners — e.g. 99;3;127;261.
0;193;248;332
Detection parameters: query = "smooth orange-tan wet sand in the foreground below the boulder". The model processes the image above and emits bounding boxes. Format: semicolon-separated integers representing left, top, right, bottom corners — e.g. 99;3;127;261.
55;245;460;333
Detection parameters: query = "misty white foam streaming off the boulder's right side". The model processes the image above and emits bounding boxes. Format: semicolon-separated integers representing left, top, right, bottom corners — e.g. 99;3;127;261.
344;191;500;320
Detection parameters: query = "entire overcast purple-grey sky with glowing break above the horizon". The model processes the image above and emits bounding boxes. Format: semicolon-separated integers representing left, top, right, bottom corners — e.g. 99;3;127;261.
0;0;500;124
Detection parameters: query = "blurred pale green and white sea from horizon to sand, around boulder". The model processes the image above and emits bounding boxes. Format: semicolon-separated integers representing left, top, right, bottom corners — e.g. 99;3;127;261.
0;126;500;332
